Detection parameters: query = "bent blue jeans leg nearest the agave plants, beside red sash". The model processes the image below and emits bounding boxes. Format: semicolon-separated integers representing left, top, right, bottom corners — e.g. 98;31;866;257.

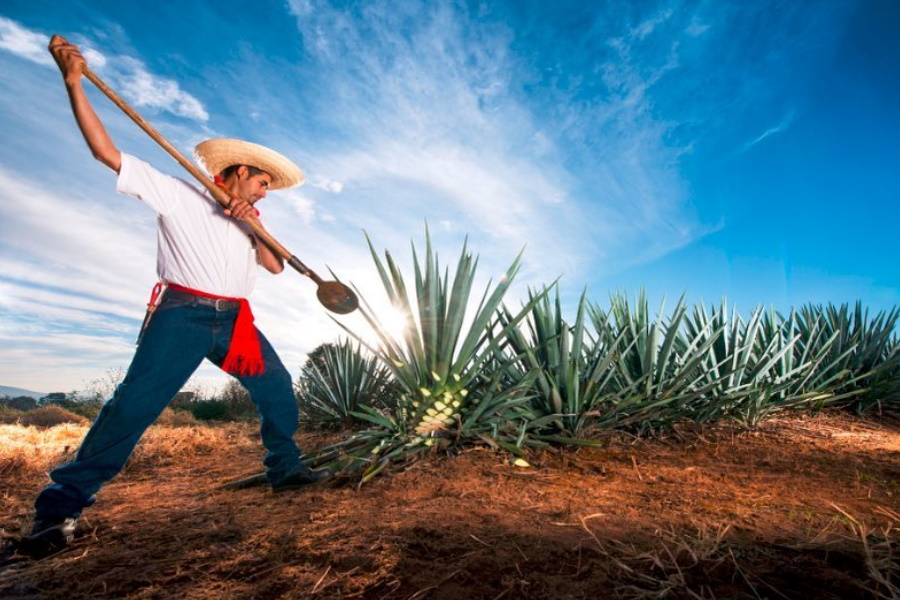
218;329;301;482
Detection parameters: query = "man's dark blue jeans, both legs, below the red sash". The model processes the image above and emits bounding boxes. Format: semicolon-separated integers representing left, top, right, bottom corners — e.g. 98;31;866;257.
35;297;302;517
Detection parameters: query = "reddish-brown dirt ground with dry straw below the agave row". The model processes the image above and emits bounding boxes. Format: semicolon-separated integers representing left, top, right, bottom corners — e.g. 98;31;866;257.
0;413;900;600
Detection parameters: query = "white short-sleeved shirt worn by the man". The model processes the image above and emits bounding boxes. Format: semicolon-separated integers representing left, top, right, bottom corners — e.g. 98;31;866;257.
116;153;257;298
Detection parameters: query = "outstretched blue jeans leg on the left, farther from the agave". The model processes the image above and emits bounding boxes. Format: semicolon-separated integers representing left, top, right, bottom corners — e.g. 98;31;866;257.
35;302;212;517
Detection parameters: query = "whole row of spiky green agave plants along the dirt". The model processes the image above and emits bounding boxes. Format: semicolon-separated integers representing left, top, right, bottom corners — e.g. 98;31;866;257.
298;231;900;481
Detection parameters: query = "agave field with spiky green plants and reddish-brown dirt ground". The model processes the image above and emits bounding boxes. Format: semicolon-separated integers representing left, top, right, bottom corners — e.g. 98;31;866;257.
0;233;900;600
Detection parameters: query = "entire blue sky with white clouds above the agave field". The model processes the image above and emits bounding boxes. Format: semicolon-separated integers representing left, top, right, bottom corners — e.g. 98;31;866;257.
0;0;900;391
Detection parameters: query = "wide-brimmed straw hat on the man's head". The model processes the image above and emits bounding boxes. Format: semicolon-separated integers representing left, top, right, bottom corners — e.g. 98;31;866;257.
194;138;306;190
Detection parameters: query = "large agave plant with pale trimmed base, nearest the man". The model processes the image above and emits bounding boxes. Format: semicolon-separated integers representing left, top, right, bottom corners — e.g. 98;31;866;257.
306;229;542;481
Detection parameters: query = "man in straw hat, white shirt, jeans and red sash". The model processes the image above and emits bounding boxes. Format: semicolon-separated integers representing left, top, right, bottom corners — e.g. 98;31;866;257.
21;36;331;556
